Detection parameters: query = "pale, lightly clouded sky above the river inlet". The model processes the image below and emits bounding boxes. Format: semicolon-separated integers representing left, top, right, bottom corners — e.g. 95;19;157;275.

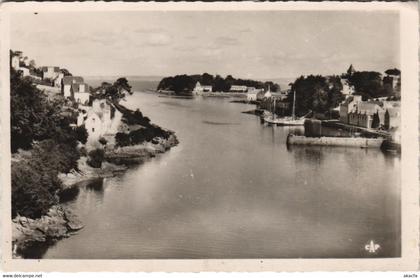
10;11;400;78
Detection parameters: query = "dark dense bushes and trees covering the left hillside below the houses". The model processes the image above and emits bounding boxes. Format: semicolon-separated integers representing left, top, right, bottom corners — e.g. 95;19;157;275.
10;69;87;218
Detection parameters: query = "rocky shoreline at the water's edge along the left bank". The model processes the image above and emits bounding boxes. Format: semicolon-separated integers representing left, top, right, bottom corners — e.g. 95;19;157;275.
12;132;178;258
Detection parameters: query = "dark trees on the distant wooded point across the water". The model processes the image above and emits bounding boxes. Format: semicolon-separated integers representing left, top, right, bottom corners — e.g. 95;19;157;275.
157;73;280;94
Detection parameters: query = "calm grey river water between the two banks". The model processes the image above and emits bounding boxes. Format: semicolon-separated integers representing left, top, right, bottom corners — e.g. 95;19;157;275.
43;93;400;259
